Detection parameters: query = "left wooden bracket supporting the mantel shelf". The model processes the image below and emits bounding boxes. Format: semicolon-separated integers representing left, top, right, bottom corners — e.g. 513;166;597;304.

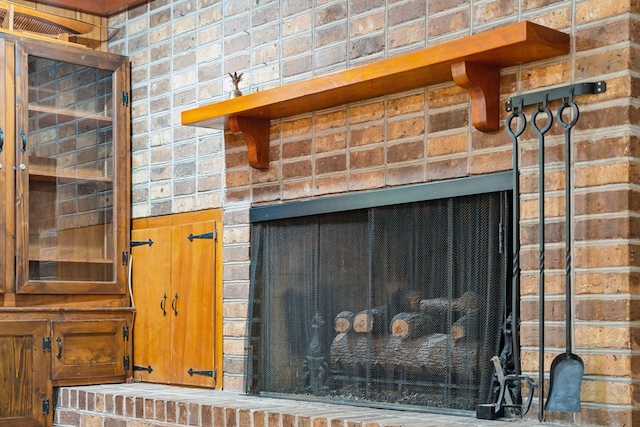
229;116;270;170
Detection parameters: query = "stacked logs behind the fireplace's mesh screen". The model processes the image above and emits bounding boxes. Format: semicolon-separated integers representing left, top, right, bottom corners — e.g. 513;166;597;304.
330;290;484;382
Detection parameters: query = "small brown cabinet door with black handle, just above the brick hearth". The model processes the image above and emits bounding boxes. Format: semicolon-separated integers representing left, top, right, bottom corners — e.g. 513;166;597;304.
51;319;128;384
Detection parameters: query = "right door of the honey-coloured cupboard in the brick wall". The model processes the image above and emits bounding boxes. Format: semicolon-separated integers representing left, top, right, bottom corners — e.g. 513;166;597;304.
171;221;216;387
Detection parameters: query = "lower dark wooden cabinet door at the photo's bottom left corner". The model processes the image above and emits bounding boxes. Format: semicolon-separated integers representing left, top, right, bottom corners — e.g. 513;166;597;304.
0;320;53;427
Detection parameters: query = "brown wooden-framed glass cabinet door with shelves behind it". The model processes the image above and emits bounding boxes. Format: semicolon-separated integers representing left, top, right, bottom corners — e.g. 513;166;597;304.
15;42;128;293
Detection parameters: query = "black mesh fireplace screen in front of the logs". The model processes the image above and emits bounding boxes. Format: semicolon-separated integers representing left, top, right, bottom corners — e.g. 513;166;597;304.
245;192;511;412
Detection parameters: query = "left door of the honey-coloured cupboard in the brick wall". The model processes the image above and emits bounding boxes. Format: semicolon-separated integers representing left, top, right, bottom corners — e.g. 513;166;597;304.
131;227;173;383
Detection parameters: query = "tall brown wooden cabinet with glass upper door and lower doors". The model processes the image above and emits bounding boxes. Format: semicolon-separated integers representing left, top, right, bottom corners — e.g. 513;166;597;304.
0;30;133;426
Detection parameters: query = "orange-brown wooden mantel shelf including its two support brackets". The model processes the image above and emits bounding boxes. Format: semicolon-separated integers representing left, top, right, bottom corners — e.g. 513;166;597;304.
182;21;570;169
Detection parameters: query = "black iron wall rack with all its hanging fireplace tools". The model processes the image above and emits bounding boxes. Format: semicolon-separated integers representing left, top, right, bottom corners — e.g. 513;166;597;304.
495;81;607;421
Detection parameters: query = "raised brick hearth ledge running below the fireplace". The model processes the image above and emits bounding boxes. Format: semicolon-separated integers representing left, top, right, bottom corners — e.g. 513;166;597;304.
54;383;558;427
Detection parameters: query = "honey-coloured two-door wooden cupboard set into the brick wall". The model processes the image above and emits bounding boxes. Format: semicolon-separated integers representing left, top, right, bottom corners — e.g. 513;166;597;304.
132;211;222;387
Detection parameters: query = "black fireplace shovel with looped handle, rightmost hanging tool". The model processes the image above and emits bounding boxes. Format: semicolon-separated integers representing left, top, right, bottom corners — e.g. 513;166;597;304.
545;99;584;412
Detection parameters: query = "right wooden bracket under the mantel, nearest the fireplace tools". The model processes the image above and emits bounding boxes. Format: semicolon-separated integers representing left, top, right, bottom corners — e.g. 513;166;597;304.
451;61;500;132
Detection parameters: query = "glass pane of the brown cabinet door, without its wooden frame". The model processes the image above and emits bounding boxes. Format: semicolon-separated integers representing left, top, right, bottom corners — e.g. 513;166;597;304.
26;56;115;281
